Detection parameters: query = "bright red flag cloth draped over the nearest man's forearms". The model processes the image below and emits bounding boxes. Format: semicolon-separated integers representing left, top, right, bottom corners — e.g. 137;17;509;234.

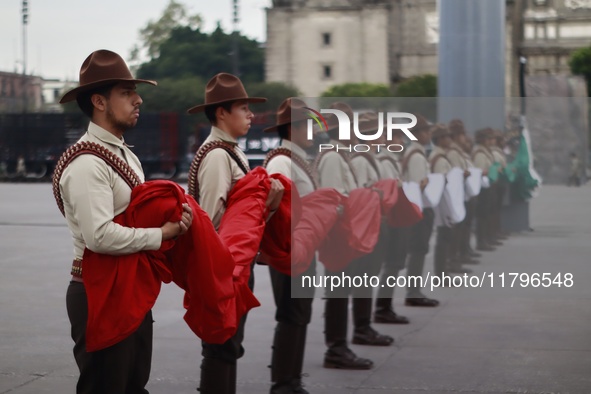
82;172;269;352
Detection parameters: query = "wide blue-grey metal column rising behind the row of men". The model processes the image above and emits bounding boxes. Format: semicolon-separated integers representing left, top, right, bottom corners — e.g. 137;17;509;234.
438;0;506;132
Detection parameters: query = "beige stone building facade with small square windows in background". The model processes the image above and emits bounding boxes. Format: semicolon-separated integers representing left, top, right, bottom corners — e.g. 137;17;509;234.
265;0;591;96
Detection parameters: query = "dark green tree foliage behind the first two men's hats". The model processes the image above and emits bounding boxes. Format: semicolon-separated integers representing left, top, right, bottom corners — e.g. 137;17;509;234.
137;26;264;83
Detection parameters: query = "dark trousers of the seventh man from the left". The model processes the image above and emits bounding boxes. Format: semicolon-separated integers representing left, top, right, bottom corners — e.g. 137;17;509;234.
406;208;435;298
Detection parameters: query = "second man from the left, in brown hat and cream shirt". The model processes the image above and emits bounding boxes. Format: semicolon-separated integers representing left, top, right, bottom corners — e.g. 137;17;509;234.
187;73;283;394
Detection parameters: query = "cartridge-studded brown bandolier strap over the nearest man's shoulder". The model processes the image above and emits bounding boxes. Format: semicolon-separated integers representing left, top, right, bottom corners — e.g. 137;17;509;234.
52;141;142;216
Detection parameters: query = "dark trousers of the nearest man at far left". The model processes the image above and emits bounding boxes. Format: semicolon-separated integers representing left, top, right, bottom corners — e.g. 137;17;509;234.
66;282;153;394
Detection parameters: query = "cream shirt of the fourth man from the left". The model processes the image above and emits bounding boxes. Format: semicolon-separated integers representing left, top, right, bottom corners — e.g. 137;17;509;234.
318;141;357;196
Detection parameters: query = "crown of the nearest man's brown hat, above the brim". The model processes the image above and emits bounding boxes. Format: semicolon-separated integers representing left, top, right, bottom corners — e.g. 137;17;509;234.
80;49;133;85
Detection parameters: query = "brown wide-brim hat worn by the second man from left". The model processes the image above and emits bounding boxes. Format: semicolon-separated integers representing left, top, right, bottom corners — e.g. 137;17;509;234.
187;73;267;114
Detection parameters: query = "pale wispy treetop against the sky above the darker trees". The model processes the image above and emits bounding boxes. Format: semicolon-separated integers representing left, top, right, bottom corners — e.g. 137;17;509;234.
131;0;203;61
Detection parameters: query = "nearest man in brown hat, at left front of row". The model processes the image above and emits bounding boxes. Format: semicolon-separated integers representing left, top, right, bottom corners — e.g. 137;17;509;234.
54;50;192;394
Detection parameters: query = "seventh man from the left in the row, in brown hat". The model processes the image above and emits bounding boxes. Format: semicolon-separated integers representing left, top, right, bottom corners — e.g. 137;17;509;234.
402;114;439;307
